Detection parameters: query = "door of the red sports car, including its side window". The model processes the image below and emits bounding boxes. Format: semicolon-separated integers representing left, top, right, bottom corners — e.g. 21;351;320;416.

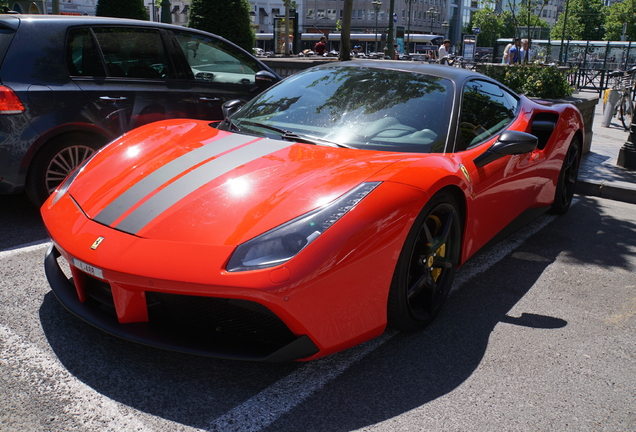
456;80;537;250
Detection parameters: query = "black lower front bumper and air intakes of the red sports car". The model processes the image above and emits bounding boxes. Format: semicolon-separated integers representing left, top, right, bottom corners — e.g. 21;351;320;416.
44;245;319;362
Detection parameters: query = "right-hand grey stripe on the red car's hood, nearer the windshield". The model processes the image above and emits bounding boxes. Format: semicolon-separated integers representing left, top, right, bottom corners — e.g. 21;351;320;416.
115;139;294;234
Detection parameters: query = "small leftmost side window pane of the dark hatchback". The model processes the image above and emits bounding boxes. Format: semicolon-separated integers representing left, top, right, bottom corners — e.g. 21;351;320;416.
66;28;106;77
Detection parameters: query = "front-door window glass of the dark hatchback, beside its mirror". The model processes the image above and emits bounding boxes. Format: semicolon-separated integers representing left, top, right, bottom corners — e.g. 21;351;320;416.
174;31;259;85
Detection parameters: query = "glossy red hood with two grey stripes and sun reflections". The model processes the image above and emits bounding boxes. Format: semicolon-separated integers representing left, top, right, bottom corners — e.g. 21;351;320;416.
69;120;404;245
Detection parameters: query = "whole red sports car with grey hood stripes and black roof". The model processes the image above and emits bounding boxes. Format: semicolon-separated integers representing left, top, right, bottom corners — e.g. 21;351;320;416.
42;61;583;361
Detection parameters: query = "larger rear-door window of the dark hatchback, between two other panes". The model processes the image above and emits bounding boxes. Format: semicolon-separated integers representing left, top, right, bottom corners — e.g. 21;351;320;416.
93;27;173;79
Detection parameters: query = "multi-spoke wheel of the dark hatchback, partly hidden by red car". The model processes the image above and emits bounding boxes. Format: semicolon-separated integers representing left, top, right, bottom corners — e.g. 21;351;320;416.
25;133;104;207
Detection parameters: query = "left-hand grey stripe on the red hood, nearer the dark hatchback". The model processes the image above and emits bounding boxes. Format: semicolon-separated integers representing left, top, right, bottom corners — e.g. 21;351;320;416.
94;134;256;226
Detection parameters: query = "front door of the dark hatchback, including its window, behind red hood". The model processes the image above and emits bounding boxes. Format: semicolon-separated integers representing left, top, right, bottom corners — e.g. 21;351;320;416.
166;30;264;120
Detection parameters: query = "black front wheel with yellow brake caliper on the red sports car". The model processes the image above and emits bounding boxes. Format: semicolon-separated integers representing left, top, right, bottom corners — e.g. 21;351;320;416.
387;192;462;331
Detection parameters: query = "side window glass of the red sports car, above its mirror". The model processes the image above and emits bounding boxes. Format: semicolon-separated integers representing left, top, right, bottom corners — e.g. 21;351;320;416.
456;80;518;151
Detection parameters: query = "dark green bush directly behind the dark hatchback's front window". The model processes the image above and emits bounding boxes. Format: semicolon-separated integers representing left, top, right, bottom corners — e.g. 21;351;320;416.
188;0;256;52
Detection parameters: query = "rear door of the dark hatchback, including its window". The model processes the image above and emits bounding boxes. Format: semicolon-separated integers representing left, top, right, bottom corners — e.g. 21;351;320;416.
67;26;196;136
